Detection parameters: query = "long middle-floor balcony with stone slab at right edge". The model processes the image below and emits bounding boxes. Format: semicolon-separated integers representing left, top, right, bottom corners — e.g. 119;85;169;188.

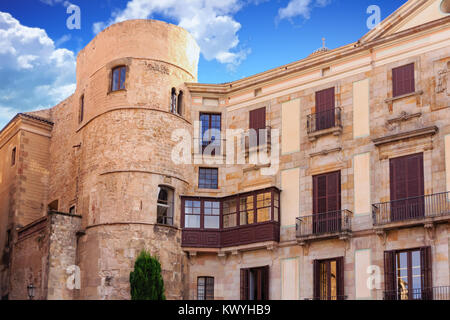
372;192;450;229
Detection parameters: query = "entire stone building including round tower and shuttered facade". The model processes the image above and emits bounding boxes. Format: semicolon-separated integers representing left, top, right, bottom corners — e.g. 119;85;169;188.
0;0;450;300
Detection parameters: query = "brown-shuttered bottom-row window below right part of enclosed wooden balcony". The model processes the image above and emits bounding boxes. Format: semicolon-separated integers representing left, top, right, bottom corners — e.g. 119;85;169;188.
241;266;269;300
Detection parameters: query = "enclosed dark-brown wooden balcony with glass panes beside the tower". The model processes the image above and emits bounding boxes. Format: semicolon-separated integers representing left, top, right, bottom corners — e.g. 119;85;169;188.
181;187;280;251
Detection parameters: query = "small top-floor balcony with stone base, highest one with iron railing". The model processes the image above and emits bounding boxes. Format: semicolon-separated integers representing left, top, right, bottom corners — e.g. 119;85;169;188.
306;108;342;141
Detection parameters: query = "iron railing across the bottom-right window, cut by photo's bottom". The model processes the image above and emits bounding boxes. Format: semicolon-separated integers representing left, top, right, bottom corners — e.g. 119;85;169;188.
383;287;450;300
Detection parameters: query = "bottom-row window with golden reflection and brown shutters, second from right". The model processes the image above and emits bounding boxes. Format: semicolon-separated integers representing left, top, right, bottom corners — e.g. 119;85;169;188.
314;257;345;300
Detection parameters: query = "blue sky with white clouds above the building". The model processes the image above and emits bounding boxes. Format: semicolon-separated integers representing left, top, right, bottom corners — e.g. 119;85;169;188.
0;0;406;128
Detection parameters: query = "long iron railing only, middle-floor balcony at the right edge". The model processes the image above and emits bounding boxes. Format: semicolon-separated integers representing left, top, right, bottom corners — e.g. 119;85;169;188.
372;192;450;225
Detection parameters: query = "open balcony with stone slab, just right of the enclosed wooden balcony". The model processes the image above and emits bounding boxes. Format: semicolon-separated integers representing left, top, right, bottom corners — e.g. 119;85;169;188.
296;210;353;244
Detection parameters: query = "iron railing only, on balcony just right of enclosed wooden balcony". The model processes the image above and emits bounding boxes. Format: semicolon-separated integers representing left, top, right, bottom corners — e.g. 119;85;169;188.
296;210;353;237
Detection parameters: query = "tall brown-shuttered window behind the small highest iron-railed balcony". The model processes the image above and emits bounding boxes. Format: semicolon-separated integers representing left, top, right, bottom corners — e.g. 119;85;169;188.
316;87;335;131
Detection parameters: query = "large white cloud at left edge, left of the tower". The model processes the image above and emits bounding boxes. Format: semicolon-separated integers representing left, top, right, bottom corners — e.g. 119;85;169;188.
0;12;76;129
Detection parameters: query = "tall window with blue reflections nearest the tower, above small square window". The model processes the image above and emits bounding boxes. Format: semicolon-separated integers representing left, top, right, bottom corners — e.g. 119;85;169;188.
200;113;221;155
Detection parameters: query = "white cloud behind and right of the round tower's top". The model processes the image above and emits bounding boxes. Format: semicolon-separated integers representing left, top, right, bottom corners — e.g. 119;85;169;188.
93;0;253;69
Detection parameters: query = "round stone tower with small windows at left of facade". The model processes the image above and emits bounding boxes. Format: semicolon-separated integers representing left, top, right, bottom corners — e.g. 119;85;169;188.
74;20;199;299
